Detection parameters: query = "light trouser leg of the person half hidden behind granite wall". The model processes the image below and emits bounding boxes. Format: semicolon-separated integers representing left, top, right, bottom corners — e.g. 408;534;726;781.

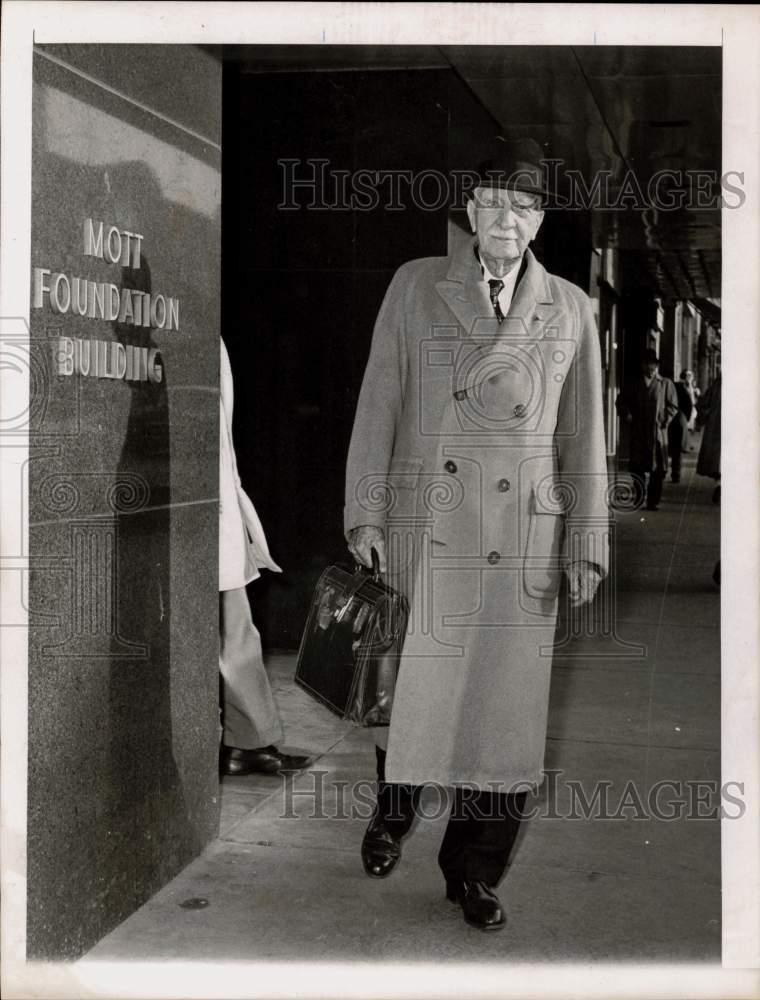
219;587;283;750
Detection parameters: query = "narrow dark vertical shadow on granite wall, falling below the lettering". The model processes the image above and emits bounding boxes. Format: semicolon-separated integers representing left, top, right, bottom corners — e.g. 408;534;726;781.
109;242;204;912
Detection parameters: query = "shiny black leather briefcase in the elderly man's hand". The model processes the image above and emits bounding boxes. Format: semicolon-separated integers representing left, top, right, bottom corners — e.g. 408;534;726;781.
295;551;409;726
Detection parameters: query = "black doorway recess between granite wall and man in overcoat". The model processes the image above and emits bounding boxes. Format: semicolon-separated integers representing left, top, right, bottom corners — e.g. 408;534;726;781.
222;49;478;649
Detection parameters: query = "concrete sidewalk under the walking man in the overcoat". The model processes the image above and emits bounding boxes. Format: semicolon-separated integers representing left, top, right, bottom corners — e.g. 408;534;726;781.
80;456;721;968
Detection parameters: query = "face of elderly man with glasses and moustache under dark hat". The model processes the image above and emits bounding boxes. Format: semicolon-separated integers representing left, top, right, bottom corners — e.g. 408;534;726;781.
467;187;544;262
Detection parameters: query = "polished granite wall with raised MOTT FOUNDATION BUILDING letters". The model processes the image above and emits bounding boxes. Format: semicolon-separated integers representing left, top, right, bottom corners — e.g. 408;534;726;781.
27;45;221;959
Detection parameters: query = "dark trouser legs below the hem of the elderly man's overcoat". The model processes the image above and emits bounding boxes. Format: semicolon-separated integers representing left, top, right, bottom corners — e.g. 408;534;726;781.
375;747;527;886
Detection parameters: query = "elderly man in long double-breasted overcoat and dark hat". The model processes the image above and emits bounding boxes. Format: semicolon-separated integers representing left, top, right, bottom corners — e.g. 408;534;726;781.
345;140;609;930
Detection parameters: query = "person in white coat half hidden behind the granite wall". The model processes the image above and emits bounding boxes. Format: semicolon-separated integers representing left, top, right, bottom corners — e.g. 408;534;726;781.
219;341;309;774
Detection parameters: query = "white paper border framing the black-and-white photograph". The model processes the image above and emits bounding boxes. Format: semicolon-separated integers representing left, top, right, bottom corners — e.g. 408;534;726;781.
0;0;760;998
